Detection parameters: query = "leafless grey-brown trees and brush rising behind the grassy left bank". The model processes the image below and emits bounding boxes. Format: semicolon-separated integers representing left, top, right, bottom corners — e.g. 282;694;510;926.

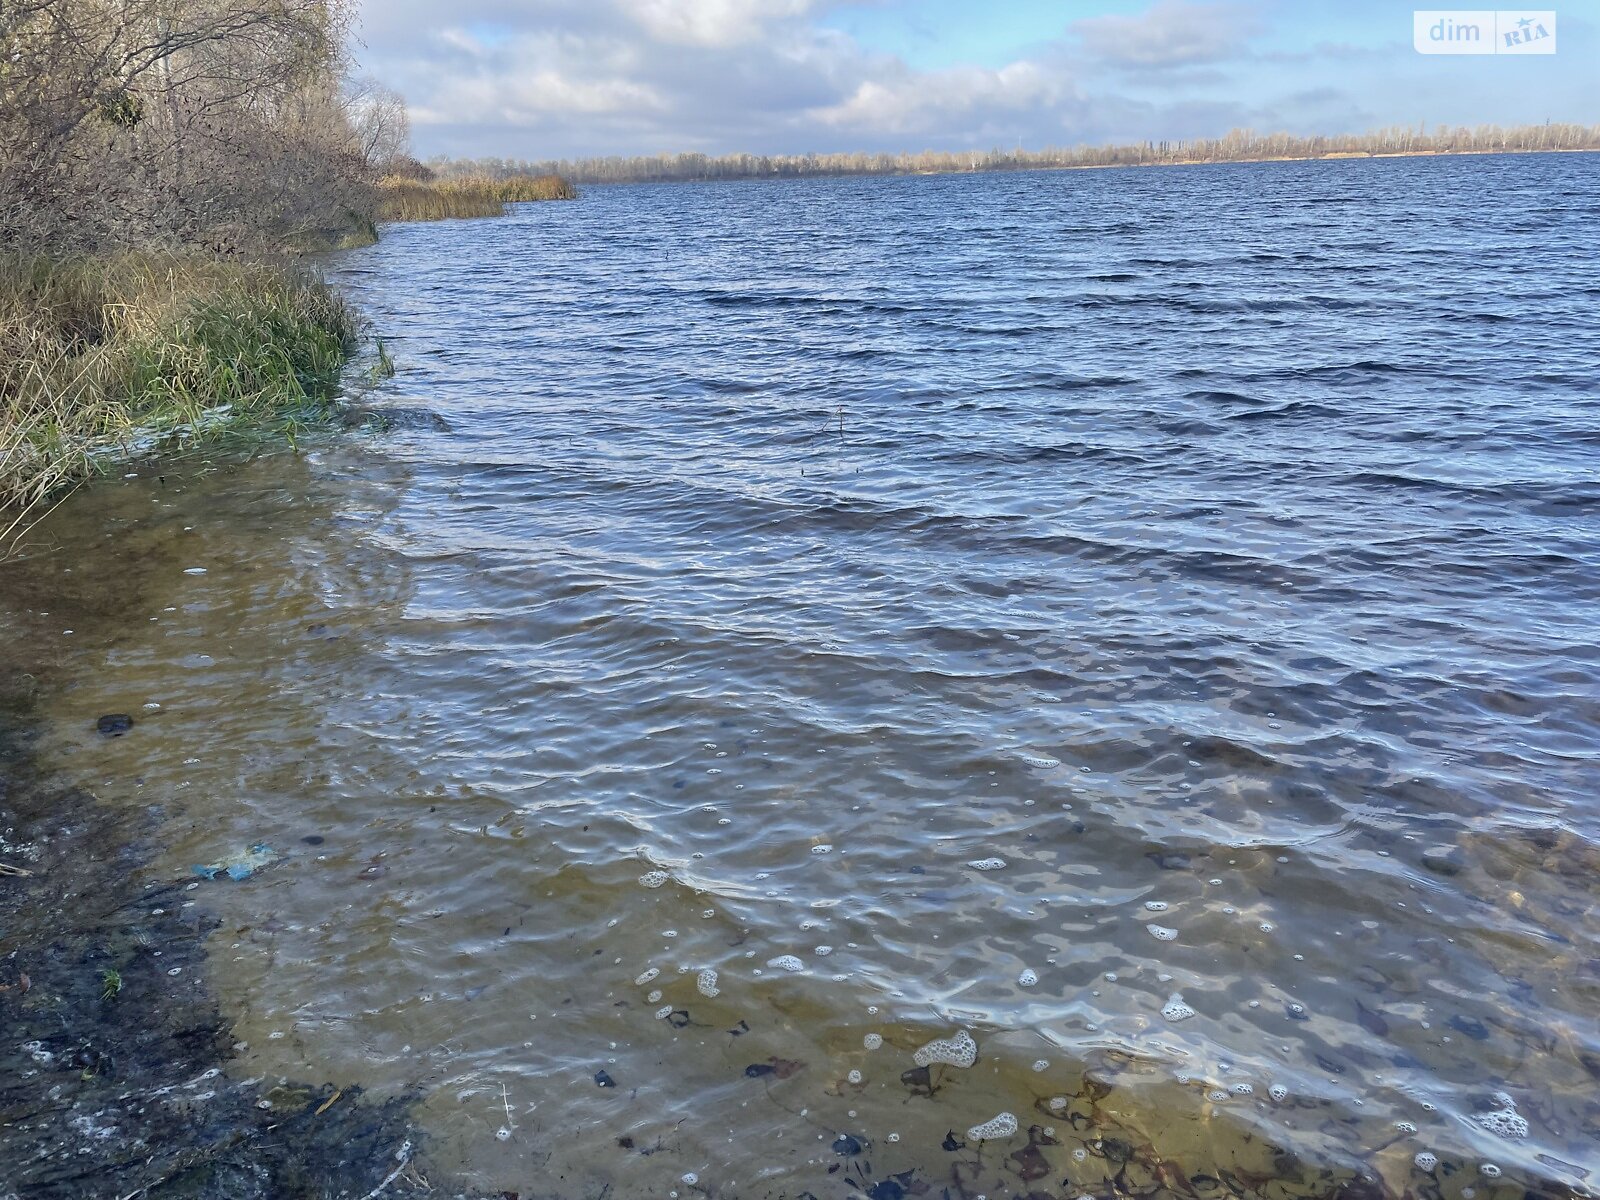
0;0;377;251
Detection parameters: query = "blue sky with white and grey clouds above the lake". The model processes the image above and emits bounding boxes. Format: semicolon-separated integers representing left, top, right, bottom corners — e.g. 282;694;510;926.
362;0;1600;158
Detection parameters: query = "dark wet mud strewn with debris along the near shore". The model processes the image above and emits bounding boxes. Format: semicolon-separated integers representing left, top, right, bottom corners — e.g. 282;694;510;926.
0;707;451;1200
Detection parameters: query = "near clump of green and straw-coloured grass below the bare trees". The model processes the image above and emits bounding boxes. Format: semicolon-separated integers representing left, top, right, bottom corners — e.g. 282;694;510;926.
0;253;357;531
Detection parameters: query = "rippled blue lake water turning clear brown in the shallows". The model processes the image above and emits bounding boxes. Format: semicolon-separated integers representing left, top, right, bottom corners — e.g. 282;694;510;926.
0;155;1600;1200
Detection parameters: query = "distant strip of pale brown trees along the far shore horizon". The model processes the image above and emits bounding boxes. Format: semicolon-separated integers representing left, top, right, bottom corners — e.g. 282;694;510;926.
429;123;1600;184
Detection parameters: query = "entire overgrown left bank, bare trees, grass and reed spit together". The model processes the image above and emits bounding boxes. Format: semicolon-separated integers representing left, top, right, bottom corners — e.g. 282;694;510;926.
0;0;573;544
